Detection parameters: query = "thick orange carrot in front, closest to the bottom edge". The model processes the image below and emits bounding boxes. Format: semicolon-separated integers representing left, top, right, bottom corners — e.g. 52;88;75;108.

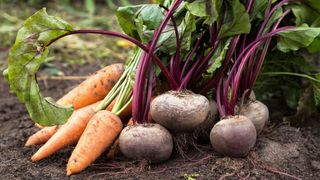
67;110;122;176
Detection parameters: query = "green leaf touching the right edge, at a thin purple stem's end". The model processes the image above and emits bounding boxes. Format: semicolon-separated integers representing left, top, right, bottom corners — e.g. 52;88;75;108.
277;24;320;52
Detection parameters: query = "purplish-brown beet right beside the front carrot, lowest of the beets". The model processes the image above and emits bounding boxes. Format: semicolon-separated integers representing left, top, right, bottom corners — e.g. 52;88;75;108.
119;123;173;163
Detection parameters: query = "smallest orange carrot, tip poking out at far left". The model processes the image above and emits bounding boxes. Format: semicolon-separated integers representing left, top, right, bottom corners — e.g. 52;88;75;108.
25;126;60;146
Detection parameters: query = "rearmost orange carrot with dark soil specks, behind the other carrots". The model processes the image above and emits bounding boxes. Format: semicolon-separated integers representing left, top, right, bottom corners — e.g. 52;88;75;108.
57;64;124;109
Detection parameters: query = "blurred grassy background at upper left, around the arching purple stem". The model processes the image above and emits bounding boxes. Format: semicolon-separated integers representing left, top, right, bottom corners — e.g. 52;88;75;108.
0;0;148;72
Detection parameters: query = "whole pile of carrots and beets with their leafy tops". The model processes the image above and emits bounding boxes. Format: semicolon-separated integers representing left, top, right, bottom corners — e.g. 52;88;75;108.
4;0;320;175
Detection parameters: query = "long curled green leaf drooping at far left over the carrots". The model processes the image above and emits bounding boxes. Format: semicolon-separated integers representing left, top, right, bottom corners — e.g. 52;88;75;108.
8;9;73;126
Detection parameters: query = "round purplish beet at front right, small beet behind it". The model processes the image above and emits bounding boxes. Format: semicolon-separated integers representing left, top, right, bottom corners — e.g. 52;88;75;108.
210;116;257;157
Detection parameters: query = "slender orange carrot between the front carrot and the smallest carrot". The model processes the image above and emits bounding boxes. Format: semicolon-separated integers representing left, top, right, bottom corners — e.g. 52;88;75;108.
31;103;97;162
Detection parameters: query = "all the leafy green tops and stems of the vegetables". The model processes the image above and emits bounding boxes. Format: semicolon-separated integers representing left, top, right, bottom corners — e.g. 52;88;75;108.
4;0;320;125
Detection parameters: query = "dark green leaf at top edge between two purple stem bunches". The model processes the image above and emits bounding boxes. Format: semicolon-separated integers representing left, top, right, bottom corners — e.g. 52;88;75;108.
218;0;251;38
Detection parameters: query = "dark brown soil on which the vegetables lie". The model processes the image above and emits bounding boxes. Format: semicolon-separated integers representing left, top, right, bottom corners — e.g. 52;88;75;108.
0;65;320;180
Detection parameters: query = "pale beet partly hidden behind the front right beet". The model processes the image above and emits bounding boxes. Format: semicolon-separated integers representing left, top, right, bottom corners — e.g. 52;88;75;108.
240;101;269;134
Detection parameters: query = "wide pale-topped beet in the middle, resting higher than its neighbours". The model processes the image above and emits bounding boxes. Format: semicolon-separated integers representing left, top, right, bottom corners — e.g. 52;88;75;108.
150;90;210;132
